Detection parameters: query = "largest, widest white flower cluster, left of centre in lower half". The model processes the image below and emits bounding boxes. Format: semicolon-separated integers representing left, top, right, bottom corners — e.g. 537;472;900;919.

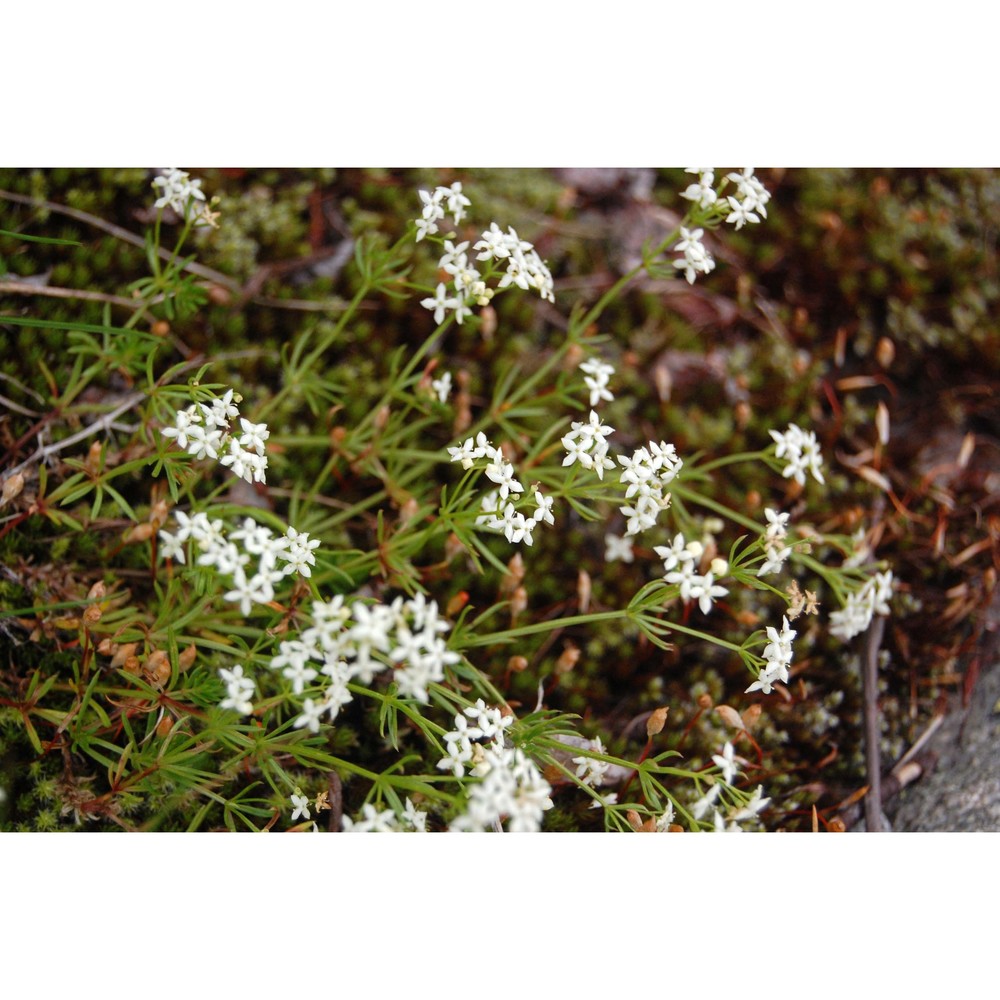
270;594;459;720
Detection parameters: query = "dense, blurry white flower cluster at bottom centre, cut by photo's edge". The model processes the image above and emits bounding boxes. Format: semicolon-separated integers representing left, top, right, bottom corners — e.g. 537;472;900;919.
437;698;552;833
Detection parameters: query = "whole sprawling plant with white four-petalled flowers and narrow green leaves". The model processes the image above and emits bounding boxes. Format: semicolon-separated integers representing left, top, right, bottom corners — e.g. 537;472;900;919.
0;169;893;832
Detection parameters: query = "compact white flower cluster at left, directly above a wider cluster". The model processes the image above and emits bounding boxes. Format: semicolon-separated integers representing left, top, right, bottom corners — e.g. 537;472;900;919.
162;389;271;483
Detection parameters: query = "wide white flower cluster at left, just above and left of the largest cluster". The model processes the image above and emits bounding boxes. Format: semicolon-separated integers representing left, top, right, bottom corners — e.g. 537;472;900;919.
159;510;319;615
